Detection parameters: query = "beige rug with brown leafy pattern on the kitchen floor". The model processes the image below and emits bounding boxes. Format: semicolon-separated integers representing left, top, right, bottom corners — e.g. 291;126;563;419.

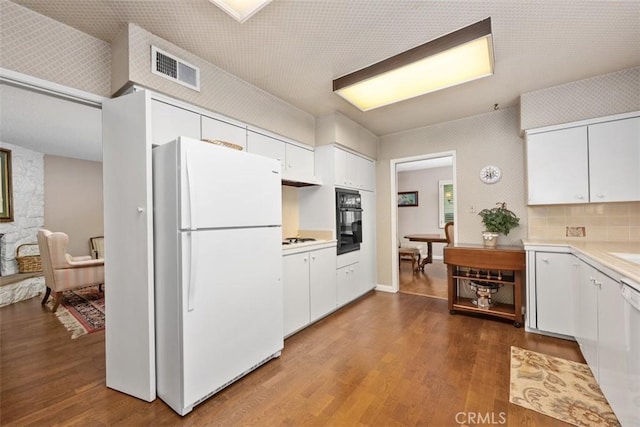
509;347;620;426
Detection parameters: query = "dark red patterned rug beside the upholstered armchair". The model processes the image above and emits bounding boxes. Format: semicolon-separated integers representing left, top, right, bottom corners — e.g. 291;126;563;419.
47;286;104;339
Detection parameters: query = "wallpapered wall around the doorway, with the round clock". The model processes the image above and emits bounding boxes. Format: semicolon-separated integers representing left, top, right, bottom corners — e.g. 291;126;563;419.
376;108;527;284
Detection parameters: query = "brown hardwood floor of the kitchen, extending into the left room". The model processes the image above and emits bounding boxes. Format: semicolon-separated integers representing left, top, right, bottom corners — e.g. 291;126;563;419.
0;292;583;426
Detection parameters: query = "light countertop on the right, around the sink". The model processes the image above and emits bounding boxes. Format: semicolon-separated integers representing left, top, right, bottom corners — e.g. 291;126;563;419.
522;239;640;283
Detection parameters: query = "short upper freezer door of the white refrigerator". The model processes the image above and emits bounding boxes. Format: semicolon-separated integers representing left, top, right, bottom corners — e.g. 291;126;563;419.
178;137;282;230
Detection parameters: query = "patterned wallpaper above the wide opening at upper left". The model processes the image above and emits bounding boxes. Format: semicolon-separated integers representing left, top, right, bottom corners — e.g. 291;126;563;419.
0;0;111;96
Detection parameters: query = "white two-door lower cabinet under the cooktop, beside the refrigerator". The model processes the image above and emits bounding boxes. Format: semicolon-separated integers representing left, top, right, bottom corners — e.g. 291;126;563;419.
282;246;336;337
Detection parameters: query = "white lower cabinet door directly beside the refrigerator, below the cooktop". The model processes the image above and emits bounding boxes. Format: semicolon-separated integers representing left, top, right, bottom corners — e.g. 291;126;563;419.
282;252;309;336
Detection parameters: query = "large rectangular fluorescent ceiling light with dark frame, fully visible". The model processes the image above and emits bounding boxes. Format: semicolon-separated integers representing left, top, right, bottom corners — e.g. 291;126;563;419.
333;18;493;111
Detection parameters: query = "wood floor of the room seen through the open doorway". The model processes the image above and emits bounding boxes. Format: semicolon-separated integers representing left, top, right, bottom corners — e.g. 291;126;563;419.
399;260;447;299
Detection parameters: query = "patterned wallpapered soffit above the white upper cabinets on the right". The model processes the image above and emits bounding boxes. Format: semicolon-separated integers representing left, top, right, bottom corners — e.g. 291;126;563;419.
520;67;640;131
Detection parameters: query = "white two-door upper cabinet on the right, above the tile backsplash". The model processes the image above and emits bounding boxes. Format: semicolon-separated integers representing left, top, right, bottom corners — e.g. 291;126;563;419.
527;113;640;205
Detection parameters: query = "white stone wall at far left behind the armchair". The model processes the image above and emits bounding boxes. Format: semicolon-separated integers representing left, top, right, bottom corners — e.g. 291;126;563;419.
0;142;44;276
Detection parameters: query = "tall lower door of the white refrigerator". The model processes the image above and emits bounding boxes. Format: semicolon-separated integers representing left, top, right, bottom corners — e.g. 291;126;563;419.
181;227;284;407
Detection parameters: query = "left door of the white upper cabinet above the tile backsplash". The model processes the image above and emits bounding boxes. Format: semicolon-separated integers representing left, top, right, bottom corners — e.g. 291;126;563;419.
527;126;589;205
